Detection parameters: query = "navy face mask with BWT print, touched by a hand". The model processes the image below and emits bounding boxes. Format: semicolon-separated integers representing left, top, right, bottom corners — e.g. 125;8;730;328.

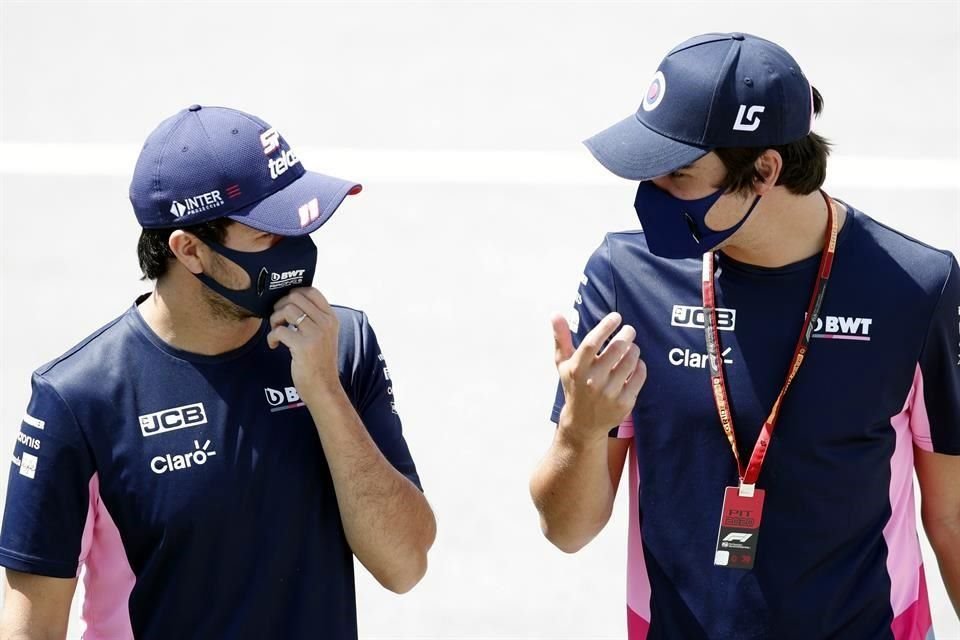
196;236;317;318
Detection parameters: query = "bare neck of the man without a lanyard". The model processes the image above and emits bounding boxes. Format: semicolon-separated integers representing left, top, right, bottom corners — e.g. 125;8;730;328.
138;274;262;356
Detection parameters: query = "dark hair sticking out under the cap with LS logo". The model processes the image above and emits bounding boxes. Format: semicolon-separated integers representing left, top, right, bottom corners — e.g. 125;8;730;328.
714;87;830;195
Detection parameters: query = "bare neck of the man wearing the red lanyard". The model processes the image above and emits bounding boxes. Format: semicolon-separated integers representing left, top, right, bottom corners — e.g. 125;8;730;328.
721;191;847;268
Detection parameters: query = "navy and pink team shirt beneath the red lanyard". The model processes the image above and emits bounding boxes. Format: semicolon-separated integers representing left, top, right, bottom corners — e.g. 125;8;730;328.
553;207;960;640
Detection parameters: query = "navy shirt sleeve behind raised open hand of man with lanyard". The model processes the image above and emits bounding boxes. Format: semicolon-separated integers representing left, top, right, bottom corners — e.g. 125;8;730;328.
550;238;633;438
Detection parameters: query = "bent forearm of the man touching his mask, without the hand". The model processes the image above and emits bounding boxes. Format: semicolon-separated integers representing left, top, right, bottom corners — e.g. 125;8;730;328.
304;390;436;593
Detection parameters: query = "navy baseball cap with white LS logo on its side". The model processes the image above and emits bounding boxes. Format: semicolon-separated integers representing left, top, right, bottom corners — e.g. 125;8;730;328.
584;33;813;181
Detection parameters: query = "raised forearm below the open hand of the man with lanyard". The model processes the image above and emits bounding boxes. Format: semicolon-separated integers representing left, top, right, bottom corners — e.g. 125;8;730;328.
530;427;615;553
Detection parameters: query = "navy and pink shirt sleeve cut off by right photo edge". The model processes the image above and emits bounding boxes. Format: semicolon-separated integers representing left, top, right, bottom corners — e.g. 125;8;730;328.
910;256;960;455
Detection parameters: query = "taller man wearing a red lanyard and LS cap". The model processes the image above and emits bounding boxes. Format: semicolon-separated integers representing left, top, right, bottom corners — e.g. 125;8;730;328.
531;34;960;640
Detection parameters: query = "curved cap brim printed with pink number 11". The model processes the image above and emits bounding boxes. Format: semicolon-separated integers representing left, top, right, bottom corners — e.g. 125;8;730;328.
227;171;363;236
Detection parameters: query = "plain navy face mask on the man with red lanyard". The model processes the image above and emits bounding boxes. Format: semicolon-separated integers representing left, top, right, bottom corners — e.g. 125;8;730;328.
633;181;760;258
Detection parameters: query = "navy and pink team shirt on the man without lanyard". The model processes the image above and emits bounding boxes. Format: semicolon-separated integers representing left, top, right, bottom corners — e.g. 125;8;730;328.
0;296;420;640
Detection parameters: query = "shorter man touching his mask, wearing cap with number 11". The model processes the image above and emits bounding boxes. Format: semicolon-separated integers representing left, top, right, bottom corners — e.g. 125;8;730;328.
0;105;435;640
